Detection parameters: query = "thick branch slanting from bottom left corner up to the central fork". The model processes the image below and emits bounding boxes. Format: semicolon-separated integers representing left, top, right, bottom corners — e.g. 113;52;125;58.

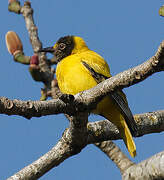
8;113;88;180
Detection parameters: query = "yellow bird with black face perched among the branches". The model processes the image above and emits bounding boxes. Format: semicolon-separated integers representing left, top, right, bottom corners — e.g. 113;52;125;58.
41;36;137;157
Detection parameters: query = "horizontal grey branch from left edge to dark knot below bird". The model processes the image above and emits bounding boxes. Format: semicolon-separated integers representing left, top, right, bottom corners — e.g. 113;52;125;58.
0;97;68;119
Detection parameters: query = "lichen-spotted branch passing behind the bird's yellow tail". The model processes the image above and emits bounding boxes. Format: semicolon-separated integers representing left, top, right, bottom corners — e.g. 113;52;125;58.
88;110;164;144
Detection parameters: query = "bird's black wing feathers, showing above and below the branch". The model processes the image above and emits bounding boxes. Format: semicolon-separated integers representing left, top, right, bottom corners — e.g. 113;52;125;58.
82;61;138;136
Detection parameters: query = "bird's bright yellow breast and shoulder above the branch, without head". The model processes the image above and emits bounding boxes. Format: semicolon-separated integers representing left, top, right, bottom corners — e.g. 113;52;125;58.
56;50;110;95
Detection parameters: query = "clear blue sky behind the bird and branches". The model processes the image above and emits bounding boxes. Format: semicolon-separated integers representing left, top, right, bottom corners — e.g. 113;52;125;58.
0;0;164;180
